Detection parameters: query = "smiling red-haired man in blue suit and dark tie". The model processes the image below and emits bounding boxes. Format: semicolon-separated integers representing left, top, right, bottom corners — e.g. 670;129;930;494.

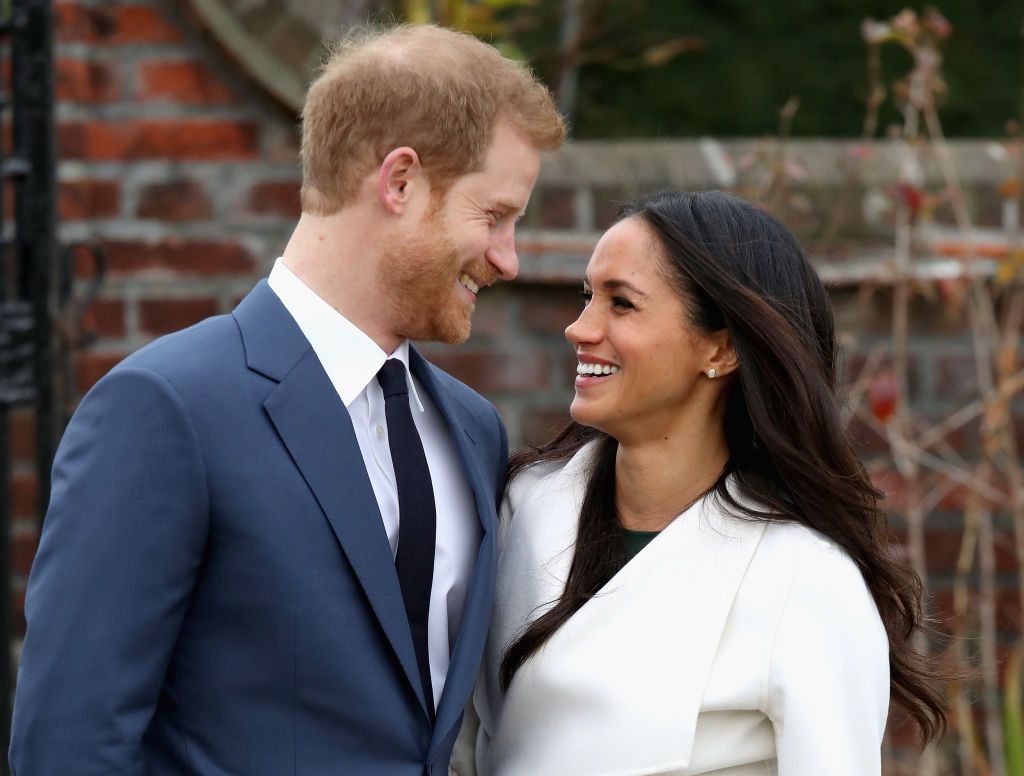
11;28;564;776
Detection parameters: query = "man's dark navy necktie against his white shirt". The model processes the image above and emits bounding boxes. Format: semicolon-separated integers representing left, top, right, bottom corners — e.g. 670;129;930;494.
377;358;437;719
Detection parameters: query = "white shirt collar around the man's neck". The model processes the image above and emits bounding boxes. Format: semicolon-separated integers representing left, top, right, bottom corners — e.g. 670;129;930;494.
267;258;423;413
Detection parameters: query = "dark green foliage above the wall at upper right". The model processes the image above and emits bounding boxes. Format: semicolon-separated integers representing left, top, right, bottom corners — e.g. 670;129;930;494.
507;0;1024;138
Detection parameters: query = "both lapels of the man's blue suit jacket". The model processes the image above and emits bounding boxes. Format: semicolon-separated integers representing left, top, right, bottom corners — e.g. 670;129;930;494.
234;281;495;735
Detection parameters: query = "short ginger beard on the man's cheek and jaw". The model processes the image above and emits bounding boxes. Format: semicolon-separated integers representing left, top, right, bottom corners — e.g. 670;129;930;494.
378;214;479;345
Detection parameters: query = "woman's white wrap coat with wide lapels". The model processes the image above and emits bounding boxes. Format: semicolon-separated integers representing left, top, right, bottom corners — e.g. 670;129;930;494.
453;443;889;776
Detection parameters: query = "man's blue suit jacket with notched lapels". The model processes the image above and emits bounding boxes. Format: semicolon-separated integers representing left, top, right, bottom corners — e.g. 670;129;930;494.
10;283;507;776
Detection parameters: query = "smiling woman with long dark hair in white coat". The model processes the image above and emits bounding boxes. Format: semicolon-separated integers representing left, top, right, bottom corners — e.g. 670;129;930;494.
457;192;945;776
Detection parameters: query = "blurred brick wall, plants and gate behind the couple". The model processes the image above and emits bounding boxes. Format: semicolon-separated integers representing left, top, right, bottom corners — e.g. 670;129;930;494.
0;0;1024;776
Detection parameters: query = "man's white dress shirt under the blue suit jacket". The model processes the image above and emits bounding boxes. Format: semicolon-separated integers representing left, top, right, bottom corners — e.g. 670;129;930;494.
267;259;481;707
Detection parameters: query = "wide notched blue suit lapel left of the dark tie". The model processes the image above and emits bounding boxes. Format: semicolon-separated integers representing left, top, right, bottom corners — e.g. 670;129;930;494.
234;282;427;714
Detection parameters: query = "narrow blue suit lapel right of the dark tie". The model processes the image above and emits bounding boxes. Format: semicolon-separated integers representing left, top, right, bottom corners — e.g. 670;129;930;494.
409;348;497;748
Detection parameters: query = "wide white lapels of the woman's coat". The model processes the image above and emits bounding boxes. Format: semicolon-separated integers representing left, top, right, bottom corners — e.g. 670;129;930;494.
481;443;765;773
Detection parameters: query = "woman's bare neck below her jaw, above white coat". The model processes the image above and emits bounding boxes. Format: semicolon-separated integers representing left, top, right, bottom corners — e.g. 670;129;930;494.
615;422;729;530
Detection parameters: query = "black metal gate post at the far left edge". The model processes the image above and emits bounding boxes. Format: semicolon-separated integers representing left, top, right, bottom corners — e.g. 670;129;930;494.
0;0;62;773
